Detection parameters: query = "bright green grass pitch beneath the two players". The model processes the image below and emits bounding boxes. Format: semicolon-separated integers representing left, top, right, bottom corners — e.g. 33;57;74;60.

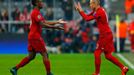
0;54;134;75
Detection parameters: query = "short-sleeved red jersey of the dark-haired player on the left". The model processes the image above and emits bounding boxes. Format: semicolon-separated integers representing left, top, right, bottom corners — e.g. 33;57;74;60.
28;8;45;39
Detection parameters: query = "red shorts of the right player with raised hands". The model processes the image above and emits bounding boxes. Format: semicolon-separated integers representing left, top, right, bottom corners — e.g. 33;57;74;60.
96;33;115;53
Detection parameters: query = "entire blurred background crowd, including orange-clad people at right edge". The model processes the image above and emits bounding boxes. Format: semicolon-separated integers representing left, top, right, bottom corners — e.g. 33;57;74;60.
0;0;134;53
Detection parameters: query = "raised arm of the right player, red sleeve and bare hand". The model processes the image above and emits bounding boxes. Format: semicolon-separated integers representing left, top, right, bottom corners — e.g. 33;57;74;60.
74;2;94;21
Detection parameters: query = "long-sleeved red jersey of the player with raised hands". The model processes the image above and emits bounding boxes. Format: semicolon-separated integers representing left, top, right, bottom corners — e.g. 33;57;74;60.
80;7;111;36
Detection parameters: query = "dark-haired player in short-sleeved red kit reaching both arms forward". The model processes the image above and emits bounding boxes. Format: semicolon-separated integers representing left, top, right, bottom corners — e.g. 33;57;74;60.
10;0;66;75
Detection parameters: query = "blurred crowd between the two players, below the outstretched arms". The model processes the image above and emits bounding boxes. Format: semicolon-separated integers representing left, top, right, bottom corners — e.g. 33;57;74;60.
45;20;99;53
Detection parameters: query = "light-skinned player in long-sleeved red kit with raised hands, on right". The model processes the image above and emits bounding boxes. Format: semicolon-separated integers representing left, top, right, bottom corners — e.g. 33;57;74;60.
75;0;128;75
